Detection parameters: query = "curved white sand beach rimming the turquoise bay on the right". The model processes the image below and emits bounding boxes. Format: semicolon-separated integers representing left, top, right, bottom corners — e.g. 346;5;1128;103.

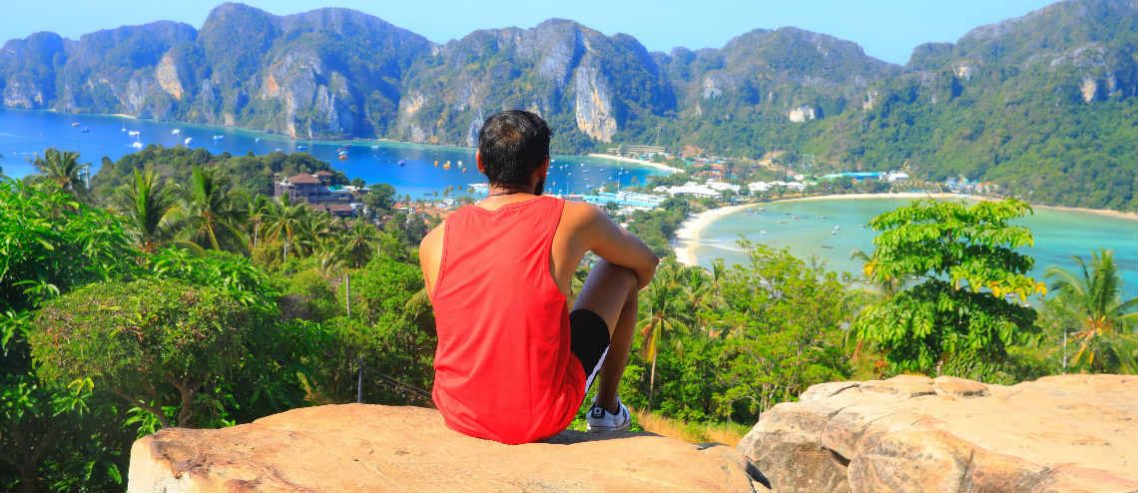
673;191;1138;266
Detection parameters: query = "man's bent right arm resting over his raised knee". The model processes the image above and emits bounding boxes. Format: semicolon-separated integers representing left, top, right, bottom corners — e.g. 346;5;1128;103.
583;205;660;289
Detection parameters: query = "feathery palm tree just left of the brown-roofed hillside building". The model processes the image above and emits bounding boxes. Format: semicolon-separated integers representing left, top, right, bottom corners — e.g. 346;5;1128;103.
170;166;245;252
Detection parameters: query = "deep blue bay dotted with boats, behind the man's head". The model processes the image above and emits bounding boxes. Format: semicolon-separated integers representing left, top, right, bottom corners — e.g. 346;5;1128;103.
0;109;661;197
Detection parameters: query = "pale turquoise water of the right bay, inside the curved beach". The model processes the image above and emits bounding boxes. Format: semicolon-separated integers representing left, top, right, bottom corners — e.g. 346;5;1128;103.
694;198;1138;297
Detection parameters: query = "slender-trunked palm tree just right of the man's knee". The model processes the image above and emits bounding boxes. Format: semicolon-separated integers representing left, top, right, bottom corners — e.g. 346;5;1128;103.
640;261;692;410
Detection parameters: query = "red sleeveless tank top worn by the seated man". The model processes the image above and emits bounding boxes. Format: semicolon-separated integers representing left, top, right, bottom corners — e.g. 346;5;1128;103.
432;197;585;444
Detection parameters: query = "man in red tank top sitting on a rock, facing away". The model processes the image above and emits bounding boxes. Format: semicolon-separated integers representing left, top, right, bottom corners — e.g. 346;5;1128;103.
419;110;659;444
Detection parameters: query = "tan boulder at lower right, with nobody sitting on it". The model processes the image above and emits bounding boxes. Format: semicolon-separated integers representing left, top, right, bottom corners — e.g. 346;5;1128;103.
739;375;1138;493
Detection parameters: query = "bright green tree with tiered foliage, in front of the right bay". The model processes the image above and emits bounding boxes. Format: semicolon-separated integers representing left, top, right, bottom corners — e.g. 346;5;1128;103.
854;199;1046;380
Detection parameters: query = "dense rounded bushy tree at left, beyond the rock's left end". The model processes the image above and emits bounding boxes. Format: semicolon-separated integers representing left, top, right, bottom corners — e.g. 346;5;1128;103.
28;279;254;427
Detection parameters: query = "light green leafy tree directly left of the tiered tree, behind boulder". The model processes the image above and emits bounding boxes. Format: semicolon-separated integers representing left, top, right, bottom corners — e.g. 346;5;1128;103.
710;241;849;422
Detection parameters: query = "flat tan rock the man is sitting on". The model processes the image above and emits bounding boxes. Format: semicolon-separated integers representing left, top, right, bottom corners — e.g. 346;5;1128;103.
127;404;752;493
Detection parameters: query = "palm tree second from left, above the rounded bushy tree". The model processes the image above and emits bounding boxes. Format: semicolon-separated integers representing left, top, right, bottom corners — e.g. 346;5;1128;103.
122;169;174;253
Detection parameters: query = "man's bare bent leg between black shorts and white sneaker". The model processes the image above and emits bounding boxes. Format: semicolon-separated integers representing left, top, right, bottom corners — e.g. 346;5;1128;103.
574;260;637;412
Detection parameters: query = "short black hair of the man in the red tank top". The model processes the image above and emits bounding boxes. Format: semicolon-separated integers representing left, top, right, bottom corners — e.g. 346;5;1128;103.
478;109;553;187
